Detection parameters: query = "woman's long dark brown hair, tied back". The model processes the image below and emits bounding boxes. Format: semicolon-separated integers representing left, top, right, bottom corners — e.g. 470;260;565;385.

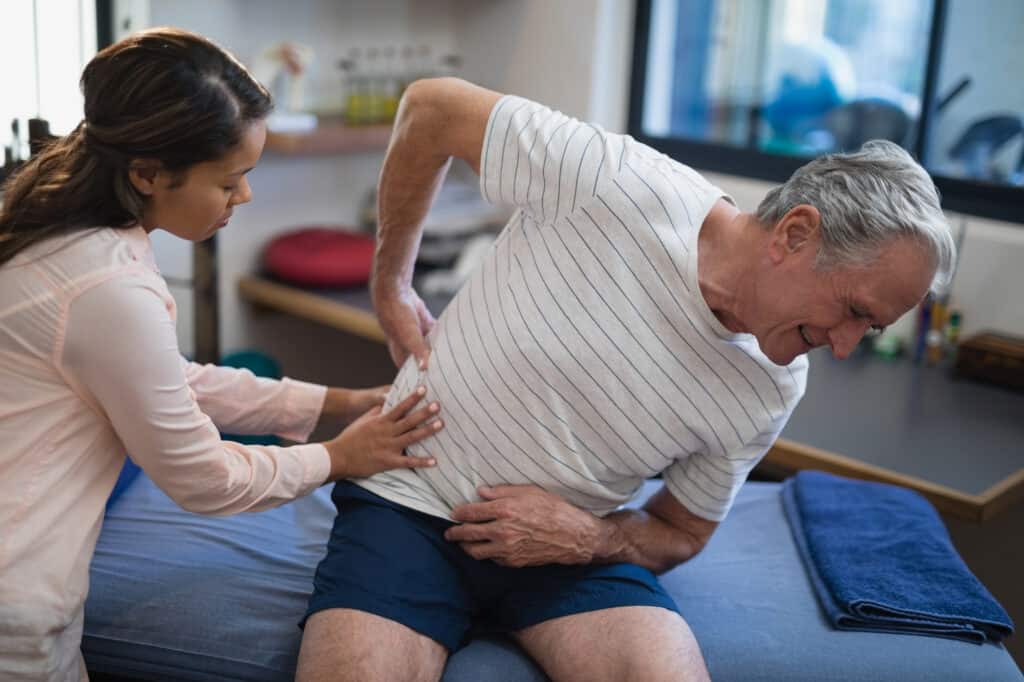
0;28;271;265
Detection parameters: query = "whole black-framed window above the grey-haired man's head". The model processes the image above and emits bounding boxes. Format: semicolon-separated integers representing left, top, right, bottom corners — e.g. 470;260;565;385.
630;0;1024;222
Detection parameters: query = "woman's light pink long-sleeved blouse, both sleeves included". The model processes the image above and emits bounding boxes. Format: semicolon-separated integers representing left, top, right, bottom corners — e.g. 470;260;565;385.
0;227;330;680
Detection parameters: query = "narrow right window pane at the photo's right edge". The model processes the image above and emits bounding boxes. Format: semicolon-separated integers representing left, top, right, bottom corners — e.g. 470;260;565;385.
925;0;1024;186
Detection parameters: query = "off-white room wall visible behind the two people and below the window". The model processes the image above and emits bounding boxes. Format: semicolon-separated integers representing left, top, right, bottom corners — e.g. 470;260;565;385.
140;0;1024;358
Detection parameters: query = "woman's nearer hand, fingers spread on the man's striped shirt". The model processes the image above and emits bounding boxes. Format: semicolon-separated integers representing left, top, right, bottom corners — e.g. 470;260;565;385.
324;387;442;481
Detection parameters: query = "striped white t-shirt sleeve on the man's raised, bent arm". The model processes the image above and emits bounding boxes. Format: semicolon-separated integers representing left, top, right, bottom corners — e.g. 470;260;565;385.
480;95;628;223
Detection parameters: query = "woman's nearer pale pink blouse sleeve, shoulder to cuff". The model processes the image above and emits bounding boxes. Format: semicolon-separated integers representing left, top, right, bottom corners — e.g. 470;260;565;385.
61;276;330;514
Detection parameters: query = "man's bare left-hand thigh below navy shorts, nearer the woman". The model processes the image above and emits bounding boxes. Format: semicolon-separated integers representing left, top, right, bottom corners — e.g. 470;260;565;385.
295;608;447;682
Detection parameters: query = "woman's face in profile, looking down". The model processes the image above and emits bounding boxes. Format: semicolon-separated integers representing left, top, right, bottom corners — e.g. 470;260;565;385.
136;121;266;242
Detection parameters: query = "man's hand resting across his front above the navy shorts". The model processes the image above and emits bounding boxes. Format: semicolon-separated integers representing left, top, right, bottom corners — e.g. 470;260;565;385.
444;485;602;567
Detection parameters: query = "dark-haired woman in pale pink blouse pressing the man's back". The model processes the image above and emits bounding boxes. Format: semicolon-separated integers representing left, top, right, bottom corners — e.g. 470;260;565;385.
0;29;440;680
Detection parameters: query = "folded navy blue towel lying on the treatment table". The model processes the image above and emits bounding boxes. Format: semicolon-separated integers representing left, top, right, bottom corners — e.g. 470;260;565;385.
782;471;1014;644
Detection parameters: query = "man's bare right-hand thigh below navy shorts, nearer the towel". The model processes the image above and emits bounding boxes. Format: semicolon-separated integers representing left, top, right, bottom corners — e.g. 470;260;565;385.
516;606;711;682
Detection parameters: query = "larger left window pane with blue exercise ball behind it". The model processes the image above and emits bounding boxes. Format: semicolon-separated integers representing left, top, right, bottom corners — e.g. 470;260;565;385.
643;0;933;156
